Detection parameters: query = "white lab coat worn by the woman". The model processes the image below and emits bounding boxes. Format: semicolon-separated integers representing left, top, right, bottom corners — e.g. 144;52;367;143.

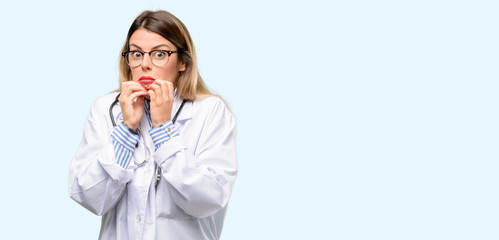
69;93;237;240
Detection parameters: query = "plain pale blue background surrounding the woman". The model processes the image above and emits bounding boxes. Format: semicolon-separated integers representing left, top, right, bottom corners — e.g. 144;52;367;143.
0;0;499;240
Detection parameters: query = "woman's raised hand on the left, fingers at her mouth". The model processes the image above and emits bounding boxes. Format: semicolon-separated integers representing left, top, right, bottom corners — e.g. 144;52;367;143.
118;81;147;130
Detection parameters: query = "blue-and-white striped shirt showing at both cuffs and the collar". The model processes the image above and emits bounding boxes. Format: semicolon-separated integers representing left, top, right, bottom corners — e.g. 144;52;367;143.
111;101;180;169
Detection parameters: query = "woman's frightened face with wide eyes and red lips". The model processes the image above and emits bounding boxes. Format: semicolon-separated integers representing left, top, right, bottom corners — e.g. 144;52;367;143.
129;28;185;85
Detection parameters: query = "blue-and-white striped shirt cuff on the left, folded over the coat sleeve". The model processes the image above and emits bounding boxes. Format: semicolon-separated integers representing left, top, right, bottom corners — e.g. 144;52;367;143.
111;123;139;168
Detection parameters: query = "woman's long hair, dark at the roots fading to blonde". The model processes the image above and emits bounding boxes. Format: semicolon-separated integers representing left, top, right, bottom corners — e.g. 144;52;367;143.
118;10;215;101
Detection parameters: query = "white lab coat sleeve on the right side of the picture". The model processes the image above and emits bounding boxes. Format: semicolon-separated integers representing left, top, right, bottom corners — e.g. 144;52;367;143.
154;98;237;218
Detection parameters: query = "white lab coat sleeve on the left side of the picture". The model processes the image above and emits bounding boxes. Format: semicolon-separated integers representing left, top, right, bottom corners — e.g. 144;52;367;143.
69;98;134;215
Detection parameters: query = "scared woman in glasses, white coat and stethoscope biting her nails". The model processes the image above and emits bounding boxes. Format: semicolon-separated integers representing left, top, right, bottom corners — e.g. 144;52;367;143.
69;11;237;240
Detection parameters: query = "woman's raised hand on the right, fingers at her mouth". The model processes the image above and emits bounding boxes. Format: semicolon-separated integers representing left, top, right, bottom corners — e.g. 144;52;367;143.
147;79;174;127
